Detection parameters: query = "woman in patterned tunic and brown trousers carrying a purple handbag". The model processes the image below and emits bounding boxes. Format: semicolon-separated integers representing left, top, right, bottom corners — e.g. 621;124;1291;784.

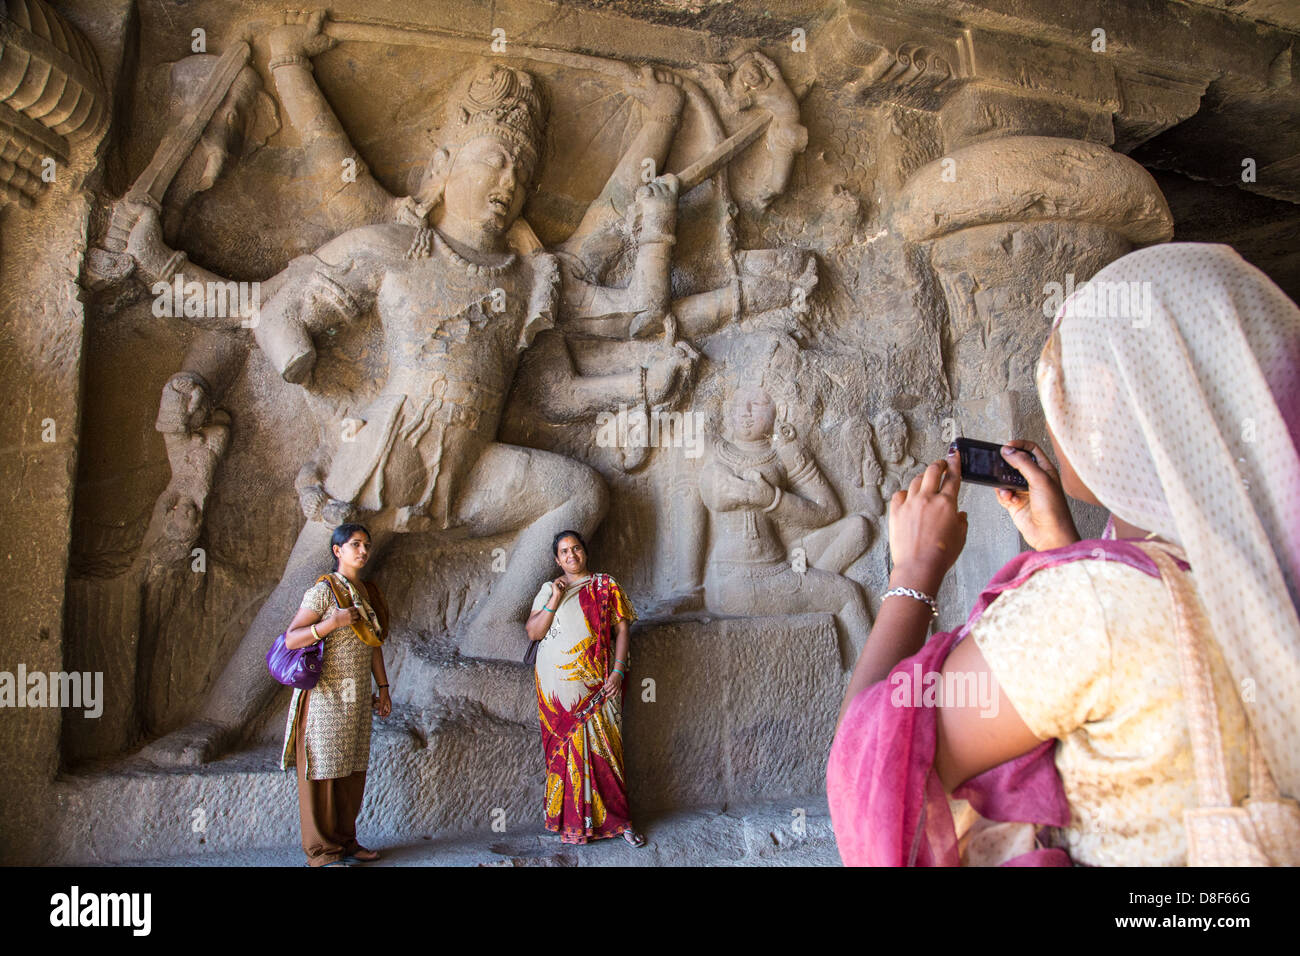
281;524;393;866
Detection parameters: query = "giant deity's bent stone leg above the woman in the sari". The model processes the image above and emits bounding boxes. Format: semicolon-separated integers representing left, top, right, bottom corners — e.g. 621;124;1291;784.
455;442;608;661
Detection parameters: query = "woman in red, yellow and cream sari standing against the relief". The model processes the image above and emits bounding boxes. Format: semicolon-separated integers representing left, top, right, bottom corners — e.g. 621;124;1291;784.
525;531;645;847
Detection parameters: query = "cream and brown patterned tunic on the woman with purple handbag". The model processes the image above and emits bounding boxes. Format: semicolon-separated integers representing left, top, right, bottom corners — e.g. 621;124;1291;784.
280;575;378;780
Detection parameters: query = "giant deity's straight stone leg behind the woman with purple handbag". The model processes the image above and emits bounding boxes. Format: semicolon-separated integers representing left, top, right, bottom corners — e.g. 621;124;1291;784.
142;522;391;766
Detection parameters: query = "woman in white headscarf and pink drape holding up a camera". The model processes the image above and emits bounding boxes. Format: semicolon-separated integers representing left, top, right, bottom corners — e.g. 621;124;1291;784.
827;243;1300;865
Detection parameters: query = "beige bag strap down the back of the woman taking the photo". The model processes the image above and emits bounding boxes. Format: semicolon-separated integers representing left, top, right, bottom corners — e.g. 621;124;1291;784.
1139;542;1278;808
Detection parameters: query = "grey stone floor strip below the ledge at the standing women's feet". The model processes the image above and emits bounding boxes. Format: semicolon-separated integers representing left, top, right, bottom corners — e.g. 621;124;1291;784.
114;796;840;866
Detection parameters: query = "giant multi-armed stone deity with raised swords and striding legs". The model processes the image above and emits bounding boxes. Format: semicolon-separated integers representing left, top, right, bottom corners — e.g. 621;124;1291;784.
68;13;821;762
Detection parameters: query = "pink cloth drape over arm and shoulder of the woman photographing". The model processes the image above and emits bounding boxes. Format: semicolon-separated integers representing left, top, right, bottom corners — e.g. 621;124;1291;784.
826;538;1190;866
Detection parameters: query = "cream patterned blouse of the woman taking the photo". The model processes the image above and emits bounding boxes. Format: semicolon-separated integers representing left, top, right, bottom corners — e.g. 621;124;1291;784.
971;545;1249;866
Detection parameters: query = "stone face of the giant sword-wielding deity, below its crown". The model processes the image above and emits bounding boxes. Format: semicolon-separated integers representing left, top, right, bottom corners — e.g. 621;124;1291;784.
439;135;530;245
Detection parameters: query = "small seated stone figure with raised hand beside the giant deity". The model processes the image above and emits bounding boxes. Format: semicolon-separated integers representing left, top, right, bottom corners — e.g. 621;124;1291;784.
699;388;871;663
